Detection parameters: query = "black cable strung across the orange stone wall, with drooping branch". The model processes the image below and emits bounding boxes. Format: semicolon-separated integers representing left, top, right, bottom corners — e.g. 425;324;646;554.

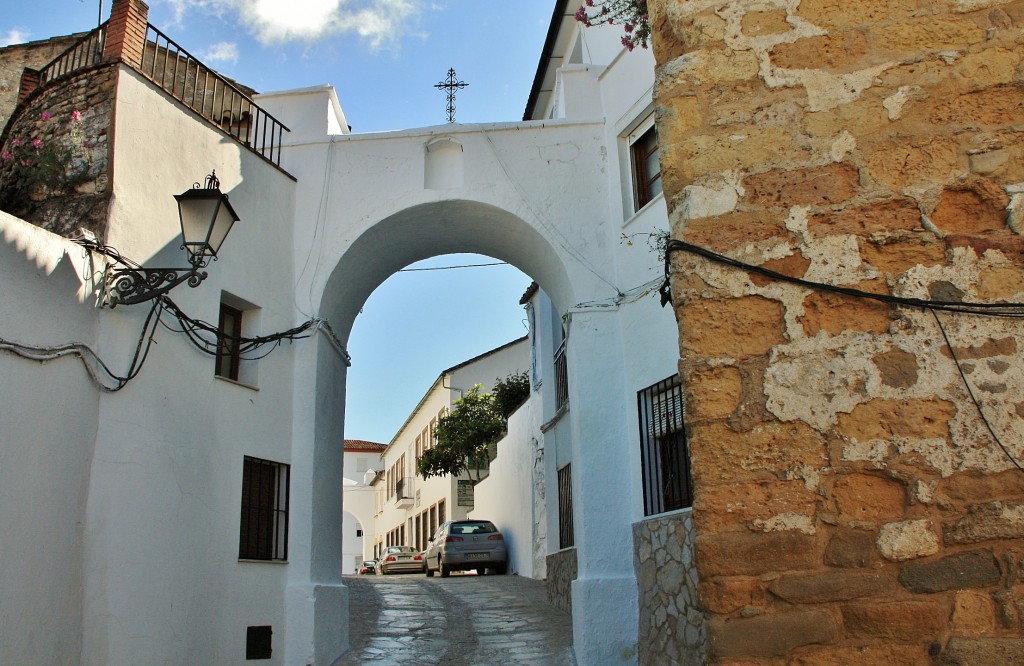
659;239;1024;471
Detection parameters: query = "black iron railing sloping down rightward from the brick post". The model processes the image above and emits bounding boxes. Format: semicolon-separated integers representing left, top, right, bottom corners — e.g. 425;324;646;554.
141;25;290;166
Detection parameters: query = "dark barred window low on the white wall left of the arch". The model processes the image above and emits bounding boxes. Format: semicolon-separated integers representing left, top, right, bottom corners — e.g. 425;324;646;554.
239;456;290;560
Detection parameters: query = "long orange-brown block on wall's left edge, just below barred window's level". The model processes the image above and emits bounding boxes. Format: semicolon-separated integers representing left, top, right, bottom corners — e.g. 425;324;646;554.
696;532;821;578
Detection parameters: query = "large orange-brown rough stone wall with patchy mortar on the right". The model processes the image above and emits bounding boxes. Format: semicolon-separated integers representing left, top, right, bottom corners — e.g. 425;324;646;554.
649;0;1024;664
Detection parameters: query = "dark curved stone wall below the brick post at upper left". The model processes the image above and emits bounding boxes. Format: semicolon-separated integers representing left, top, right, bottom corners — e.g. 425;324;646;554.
0;65;118;240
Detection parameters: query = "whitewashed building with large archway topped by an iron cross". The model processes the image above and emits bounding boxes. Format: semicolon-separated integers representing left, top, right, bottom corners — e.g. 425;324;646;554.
0;0;677;665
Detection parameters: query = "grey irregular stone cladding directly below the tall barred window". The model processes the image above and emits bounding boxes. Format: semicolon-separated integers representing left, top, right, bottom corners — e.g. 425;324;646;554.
633;511;707;666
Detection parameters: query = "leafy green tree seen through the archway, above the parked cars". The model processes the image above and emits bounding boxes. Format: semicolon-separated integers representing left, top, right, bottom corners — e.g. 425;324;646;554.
416;372;529;481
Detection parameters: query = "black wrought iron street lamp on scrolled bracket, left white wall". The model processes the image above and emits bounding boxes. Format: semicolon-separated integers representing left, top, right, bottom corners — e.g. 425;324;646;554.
105;171;239;307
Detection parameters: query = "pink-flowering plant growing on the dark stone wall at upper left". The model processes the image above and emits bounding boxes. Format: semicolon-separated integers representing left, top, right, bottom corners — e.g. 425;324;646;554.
0;111;89;210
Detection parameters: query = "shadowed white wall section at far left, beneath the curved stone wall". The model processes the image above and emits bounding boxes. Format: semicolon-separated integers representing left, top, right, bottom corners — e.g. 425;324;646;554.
0;212;99;664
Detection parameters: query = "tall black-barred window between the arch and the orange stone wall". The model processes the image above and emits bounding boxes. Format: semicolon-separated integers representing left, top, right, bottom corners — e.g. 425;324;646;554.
637;375;693;515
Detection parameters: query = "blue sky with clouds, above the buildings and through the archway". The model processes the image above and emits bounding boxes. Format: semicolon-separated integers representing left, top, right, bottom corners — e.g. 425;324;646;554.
0;0;555;443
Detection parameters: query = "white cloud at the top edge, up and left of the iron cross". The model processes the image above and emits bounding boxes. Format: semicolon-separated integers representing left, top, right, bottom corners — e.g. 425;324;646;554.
158;0;423;49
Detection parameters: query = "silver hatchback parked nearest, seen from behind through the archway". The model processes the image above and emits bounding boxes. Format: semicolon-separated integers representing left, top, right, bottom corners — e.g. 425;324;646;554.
423;521;509;578
